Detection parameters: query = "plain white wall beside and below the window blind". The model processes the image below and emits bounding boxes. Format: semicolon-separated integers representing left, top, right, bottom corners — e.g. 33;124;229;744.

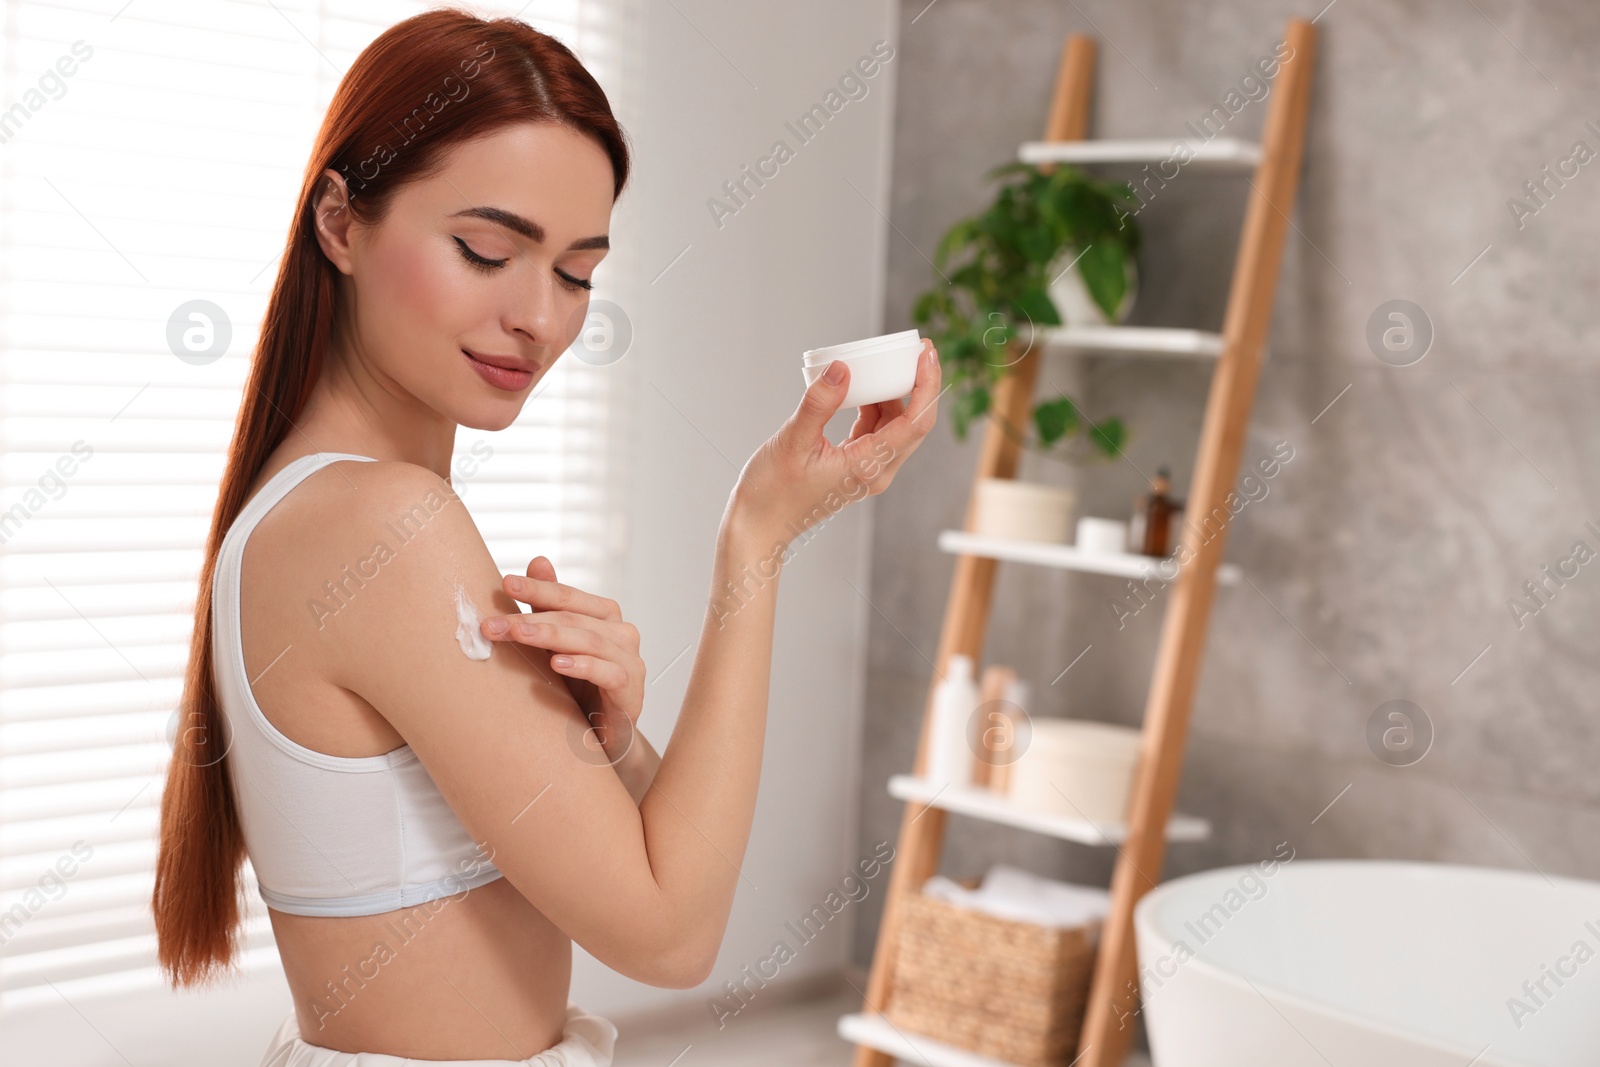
5;0;898;1067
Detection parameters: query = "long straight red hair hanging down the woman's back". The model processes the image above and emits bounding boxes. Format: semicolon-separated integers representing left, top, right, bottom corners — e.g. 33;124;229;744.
150;8;629;987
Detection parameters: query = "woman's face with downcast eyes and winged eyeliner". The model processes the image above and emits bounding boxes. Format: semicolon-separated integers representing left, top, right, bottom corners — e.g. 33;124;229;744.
318;123;613;430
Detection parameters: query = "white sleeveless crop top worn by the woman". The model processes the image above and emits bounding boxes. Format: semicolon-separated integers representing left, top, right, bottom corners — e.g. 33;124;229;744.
211;453;501;915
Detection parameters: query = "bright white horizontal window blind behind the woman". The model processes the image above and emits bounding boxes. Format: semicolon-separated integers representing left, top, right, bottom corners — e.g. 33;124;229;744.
0;0;642;1013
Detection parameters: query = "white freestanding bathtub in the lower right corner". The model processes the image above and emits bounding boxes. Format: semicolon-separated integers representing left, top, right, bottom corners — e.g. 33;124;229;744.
1134;848;1600;1067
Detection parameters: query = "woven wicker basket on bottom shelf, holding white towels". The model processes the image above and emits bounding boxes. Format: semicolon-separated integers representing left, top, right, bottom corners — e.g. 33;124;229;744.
885;878;1099;1067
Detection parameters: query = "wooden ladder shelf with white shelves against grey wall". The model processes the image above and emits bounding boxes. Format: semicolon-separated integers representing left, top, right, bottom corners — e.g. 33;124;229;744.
838;19;1317;1067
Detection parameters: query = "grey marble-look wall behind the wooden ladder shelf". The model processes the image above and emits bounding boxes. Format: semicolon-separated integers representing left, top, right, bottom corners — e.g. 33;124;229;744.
856;0;1600;965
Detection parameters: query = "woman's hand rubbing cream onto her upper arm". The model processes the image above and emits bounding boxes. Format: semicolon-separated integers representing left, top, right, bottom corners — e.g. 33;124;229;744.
482;555;645;763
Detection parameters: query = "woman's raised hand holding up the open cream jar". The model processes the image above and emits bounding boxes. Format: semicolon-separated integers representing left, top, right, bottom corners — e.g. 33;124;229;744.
728;338;941;544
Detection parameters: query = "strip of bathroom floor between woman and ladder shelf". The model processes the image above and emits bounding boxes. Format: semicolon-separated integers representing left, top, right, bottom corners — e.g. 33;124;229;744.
613;976;1150;1067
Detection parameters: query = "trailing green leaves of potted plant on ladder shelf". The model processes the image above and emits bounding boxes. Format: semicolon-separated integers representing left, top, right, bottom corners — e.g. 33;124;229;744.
912;163;1139;459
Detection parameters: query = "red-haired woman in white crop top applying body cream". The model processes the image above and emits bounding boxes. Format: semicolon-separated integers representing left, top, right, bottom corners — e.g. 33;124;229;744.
152;10;939;1067
